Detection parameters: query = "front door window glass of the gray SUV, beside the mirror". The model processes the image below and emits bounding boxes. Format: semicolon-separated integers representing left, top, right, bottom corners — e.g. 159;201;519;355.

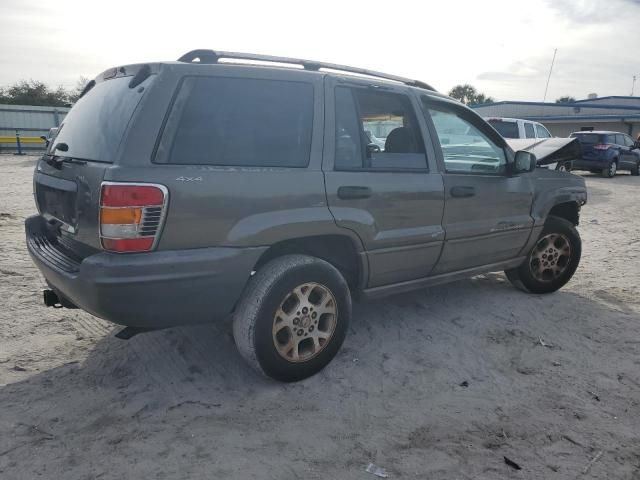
425;105;507;174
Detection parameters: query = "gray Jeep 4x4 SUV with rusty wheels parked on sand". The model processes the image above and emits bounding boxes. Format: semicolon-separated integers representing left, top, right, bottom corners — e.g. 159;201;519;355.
26;50;587;381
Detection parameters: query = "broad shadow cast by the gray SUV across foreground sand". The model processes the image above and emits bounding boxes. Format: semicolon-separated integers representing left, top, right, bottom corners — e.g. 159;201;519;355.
0;274;640;478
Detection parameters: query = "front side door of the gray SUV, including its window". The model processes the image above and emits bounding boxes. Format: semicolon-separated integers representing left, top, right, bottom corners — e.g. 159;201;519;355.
421;95;533;273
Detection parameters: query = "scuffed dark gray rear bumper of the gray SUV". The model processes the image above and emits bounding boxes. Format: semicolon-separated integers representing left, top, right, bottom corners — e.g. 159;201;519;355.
25;216;266;329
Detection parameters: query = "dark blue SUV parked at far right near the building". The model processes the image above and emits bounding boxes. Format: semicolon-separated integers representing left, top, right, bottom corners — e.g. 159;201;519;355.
571;131;640;178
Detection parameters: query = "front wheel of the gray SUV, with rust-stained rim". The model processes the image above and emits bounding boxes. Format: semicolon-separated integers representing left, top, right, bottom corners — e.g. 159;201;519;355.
505;216;582;293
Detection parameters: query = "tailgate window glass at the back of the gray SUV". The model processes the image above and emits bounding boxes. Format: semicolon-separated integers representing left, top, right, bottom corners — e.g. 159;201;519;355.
48;75;155;162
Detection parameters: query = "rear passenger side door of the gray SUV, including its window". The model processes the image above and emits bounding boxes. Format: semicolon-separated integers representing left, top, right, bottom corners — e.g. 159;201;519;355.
323;77;444;287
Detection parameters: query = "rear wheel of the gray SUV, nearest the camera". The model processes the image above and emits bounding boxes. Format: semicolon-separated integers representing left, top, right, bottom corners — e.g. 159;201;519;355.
233;255;351;382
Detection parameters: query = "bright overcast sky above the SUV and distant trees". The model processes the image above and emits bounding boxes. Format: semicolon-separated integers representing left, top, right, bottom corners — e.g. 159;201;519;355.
0;0;640;101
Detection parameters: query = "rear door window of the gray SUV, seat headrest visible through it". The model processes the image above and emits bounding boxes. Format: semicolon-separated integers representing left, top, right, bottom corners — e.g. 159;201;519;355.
335;87;427;170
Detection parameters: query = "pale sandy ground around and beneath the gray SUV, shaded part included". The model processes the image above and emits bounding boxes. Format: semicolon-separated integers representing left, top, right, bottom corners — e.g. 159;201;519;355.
0;156;640;480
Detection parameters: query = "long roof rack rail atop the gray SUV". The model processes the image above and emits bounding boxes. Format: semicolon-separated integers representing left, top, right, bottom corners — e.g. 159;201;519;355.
178;50;436;92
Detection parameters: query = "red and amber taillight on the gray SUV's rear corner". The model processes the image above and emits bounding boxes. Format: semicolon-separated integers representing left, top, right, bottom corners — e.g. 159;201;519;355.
100;182;168;253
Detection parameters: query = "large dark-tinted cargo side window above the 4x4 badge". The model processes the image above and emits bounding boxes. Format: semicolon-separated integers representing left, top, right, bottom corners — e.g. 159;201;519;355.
156;77;313;167
